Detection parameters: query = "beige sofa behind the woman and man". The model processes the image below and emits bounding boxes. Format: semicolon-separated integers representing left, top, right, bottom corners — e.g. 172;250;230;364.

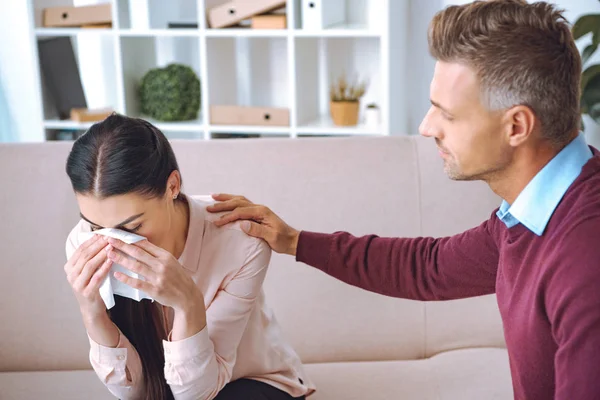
0;137;512;400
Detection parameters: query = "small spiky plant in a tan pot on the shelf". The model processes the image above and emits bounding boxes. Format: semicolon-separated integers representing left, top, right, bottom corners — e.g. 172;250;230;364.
329;75;367;126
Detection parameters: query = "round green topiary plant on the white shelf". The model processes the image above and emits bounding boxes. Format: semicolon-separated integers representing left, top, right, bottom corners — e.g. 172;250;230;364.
140;64;200;121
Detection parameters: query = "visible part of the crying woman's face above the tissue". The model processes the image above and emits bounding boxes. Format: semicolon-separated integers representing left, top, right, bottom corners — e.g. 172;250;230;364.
76;175;179;247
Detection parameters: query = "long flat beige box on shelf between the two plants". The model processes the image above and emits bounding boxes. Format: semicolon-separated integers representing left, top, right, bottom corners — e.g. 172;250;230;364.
210;105;290;126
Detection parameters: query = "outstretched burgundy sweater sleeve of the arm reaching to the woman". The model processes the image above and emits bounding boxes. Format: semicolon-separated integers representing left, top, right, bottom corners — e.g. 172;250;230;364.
296;214;499;300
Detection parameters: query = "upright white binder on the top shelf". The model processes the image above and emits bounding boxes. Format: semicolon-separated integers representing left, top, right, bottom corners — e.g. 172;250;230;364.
302;0;346;31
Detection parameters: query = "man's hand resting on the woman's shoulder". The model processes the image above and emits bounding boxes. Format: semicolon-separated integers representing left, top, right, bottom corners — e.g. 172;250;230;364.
207;194;300;256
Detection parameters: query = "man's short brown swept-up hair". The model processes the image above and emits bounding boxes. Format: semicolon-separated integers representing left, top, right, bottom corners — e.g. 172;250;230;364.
428;0;581;147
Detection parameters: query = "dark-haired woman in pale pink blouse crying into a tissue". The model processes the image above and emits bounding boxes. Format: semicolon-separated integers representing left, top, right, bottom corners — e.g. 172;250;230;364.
65;114;314;400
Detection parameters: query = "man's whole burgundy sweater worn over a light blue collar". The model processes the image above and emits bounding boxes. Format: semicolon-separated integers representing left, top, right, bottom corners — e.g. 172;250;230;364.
296;154;600;400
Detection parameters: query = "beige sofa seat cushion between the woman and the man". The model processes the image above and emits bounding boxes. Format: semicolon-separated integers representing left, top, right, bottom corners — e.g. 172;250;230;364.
306;348;513;400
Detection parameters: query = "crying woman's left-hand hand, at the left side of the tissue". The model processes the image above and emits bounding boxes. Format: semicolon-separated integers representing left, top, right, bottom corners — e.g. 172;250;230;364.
64;235;112;320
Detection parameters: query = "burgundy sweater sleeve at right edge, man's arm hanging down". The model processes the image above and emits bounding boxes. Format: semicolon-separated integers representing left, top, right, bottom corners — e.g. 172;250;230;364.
544;217;600;400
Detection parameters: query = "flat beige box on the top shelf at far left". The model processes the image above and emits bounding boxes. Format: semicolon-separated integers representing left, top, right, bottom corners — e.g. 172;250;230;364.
43;3;112;27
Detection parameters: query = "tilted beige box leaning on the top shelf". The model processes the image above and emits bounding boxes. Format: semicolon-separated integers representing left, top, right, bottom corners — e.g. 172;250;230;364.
208;0;286;28
